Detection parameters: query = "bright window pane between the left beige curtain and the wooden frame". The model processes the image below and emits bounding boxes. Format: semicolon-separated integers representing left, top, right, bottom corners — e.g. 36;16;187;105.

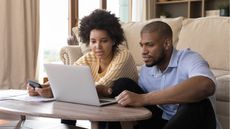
39;0;68;80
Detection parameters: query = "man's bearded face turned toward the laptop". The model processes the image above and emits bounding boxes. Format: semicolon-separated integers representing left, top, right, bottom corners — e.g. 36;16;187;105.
140;32;165;67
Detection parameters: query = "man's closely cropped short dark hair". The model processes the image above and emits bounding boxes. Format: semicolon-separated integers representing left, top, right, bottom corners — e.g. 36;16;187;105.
141;21;173;39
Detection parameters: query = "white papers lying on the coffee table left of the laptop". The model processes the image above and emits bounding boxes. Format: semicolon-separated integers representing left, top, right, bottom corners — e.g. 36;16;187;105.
0;89;55;102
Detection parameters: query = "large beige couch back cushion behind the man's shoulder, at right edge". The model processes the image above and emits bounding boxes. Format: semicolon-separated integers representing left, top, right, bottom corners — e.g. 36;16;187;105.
177;17;230;70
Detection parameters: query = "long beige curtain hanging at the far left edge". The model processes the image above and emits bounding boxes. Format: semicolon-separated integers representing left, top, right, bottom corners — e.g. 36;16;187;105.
0;0;39;89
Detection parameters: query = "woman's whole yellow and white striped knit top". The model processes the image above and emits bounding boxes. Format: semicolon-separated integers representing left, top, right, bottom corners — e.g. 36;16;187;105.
74;48;138;86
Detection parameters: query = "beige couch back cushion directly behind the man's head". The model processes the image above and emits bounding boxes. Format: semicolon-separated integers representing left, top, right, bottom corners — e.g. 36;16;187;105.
122;17;183;65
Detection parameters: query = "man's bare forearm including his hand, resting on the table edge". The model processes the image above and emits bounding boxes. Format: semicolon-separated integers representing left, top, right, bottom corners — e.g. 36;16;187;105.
117;76;215;106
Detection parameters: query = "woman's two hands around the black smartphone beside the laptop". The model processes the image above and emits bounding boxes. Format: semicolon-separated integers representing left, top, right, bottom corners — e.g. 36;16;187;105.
27;83;53;98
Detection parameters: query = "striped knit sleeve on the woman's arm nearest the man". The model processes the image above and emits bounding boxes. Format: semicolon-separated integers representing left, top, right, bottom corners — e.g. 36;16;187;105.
96;50;138;86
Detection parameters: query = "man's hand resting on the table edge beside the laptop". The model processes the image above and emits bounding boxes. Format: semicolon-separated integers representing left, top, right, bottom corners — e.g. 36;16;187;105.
115;90;145;106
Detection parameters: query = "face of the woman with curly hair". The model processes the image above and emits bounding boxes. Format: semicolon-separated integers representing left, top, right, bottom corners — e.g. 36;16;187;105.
89;29;113;60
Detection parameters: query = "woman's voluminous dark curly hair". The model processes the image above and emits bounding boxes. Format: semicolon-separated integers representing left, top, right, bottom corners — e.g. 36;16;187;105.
79;9;125;48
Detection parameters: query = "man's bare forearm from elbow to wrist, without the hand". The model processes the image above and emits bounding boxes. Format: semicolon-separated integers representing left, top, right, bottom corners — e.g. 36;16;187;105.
145;76;215;104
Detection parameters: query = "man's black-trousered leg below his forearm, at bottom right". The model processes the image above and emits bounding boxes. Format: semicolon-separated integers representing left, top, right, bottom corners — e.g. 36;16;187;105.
164;99;216;129
